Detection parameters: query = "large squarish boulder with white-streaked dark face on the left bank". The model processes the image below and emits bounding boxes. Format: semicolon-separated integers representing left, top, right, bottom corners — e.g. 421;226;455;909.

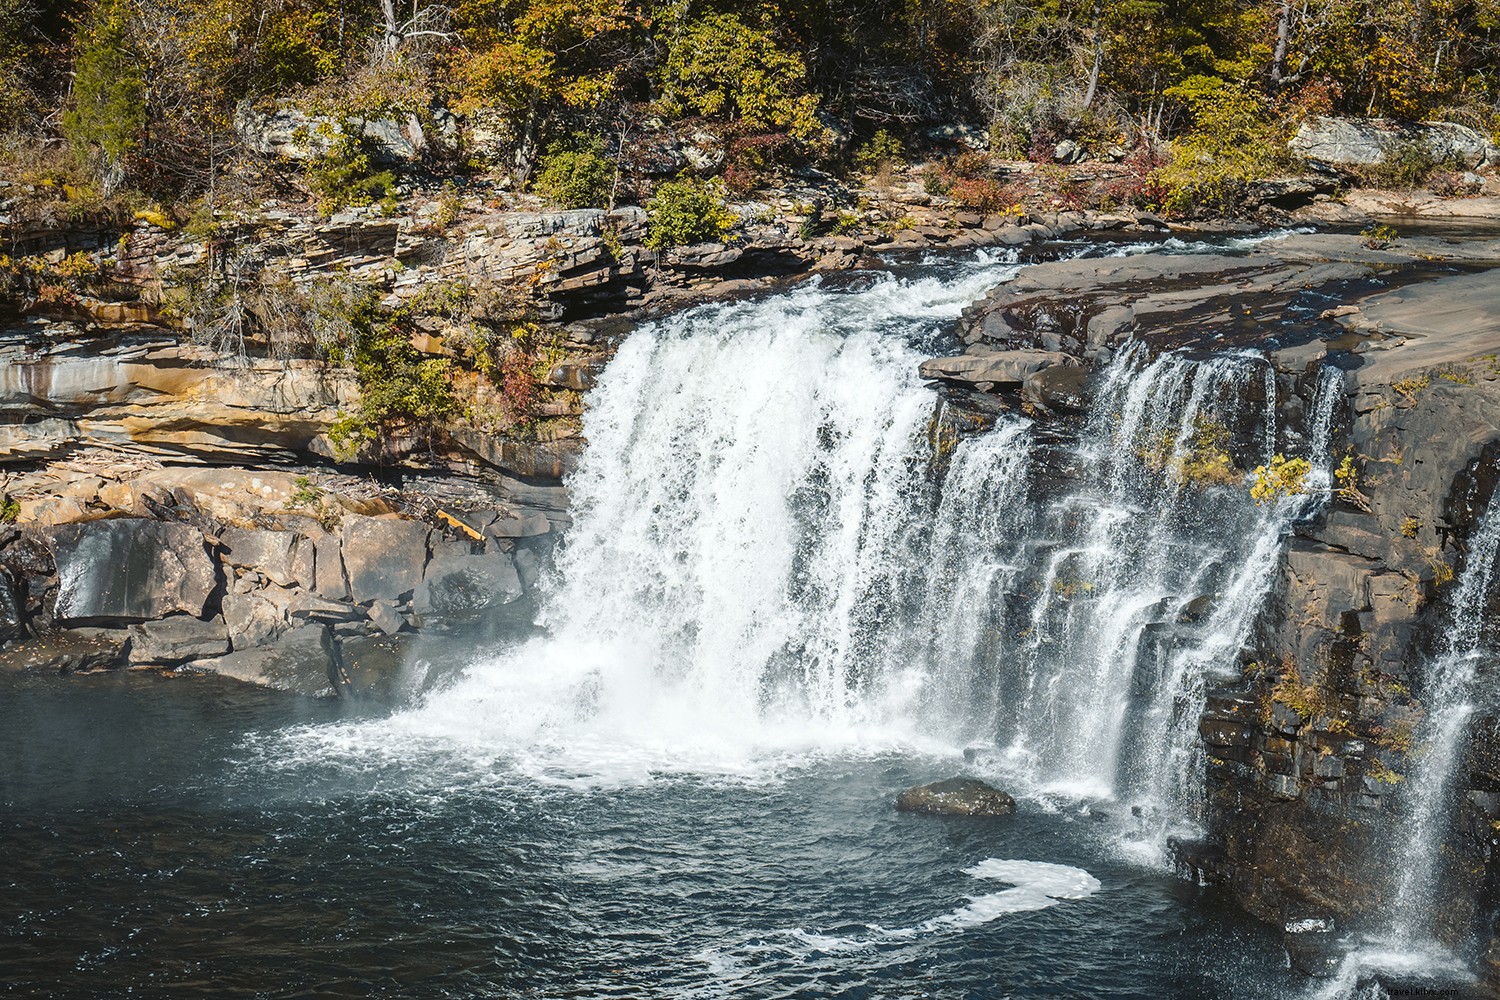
51;517;219;624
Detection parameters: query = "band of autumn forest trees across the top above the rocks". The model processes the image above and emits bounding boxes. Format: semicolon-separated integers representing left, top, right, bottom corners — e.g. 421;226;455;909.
0;0;1500;198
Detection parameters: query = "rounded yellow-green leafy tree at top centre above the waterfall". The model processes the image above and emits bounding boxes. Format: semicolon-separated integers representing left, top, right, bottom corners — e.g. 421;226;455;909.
662;13;821;139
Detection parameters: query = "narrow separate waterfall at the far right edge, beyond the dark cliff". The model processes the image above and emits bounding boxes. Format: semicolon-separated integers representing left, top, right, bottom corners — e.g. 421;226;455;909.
1392;501;1500;943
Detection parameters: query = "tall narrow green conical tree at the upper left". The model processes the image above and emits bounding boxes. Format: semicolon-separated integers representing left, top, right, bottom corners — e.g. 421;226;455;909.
63;0;146;171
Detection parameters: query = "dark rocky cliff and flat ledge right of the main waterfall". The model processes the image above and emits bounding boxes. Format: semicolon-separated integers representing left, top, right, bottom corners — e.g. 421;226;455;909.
942;235;1500;979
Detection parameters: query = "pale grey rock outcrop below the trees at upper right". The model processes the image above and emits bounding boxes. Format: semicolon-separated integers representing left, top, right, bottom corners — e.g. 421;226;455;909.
1289;115;1500;168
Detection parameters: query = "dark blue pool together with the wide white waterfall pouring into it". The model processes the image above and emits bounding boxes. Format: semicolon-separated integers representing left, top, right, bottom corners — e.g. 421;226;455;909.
0;238;1434;997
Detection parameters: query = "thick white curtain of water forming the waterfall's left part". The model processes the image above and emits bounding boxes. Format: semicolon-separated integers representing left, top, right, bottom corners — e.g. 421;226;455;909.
375;251;1026;775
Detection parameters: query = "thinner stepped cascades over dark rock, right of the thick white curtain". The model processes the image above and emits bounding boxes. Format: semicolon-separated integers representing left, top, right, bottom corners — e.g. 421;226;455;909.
933;346;1335;859
